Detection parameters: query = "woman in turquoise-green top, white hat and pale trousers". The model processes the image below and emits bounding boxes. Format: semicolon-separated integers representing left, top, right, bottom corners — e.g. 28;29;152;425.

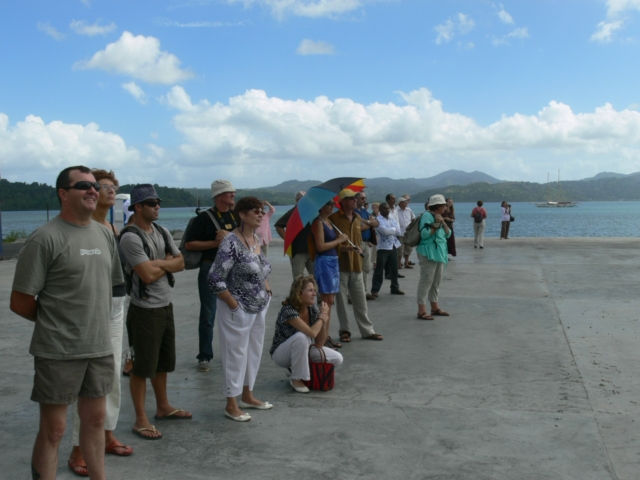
416;194;451;320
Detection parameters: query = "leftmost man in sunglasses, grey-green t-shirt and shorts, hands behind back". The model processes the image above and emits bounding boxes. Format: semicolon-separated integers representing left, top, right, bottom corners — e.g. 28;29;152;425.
11;166;123;479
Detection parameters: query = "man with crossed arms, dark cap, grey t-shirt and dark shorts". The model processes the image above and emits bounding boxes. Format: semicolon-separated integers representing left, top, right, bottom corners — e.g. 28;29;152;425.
120;184;191;439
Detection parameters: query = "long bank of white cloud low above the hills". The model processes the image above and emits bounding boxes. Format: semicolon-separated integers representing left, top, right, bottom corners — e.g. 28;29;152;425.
5;86;640;186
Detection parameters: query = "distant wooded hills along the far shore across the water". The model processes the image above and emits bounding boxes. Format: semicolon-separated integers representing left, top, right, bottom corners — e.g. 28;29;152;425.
0;170;640;210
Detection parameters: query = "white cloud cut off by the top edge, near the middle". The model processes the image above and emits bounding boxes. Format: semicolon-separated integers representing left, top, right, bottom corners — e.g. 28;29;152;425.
227;0;364;18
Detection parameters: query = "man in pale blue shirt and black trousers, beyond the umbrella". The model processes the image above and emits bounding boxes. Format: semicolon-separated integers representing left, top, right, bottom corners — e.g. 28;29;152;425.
371;203;404;297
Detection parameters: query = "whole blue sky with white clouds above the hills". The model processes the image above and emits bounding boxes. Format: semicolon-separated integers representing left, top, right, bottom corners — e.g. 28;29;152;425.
0;0;640;187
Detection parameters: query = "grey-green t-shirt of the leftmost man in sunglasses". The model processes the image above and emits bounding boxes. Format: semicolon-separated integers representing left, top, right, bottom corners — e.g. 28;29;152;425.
12;216;124;360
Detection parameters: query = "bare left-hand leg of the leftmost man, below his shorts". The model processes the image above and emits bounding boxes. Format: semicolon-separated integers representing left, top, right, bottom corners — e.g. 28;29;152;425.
31;404;67;480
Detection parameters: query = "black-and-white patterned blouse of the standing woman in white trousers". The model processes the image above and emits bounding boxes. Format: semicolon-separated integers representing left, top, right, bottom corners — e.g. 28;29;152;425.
209;233;271;313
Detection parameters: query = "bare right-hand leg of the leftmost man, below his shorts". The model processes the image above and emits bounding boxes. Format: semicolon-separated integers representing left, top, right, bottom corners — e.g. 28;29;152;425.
78;397;106;480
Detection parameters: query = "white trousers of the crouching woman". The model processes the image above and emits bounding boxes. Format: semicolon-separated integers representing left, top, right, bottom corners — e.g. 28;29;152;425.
271;332;342;380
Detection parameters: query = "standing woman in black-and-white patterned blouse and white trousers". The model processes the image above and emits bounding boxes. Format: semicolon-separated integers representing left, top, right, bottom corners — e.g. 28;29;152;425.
209;197;273;422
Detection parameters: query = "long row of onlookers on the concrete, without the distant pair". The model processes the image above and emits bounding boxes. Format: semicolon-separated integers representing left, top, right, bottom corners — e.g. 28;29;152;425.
10;166;464;479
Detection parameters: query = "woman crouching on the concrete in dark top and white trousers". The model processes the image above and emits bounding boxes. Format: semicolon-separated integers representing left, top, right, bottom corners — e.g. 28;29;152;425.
269;275;342;393
